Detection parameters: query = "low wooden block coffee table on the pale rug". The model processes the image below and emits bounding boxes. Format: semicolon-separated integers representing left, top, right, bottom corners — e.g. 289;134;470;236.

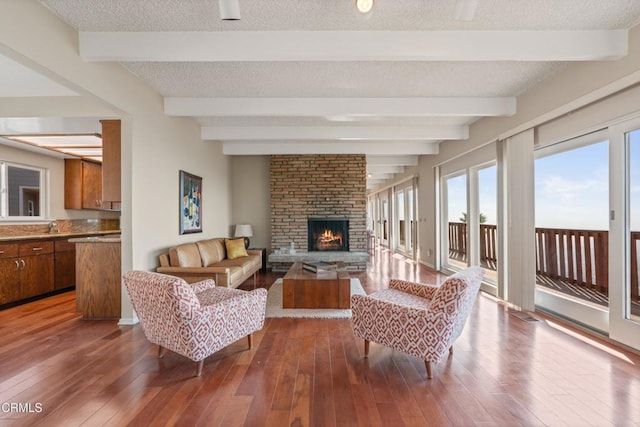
282;262;351;308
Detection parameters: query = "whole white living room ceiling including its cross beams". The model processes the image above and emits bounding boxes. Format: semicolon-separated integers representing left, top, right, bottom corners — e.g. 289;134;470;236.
0;0;640;187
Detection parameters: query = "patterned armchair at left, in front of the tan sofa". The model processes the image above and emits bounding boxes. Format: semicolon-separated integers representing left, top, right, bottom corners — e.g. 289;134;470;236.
124;271;267;376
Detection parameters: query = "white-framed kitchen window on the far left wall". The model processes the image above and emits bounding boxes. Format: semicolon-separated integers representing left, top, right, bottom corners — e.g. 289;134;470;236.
0;162;46;221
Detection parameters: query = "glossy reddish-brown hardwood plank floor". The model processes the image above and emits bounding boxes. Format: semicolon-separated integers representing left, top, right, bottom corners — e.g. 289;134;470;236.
0;251;640;426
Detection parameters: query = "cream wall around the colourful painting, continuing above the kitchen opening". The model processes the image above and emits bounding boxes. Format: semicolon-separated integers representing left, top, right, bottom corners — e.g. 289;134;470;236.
0;0;231;322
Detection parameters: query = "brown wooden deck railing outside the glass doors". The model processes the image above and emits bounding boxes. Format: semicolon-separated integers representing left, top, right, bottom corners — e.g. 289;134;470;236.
449;222;640;301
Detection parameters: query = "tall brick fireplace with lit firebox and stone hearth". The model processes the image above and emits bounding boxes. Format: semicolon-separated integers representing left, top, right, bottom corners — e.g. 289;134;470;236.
268;154;369;270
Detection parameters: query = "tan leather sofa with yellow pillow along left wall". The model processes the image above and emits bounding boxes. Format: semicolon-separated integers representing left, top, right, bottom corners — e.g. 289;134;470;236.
156;238;262;288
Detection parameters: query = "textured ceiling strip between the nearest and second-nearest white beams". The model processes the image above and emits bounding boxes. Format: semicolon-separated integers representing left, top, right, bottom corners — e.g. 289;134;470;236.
124;61;562;97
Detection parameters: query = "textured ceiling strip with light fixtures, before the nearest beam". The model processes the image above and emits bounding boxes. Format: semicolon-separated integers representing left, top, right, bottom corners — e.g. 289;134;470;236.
37;0;640;31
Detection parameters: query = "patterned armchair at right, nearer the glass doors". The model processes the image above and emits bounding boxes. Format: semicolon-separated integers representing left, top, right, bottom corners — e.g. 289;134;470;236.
351;267;484;378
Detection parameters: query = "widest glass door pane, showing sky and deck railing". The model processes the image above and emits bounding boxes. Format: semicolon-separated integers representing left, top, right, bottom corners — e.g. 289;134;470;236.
535;132;609;331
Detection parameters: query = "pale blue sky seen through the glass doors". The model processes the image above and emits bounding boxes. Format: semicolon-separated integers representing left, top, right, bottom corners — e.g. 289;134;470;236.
447;135;640;231
